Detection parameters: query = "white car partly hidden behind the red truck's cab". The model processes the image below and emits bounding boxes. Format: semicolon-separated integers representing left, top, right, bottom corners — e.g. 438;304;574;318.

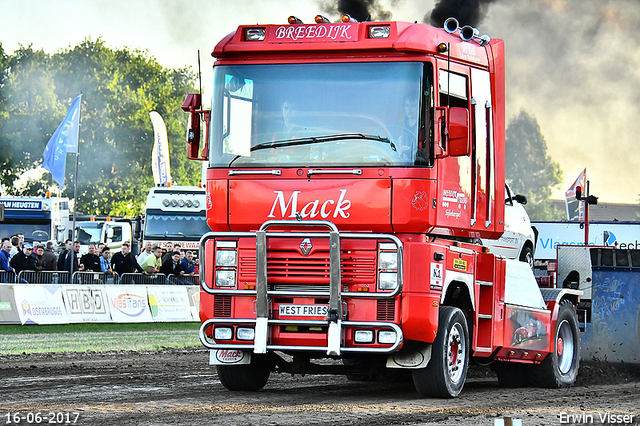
482;185;537;268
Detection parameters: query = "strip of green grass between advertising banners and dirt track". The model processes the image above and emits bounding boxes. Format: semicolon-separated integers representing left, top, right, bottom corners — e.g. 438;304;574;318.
0;322;201;355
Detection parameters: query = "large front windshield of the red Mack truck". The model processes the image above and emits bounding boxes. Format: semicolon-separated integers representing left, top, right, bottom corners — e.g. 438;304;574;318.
209;62;431;168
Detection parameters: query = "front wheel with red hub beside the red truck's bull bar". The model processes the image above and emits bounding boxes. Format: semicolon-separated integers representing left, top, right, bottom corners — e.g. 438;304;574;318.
412;306;469;398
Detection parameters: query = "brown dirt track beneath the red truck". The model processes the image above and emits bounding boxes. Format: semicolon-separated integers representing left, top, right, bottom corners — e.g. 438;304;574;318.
0;349;640;426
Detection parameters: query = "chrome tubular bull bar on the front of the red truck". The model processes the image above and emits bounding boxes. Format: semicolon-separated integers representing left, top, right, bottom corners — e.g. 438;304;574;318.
200;220;403;355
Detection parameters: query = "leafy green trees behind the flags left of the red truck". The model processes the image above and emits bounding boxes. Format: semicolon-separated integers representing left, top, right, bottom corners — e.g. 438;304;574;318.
0;39;200;216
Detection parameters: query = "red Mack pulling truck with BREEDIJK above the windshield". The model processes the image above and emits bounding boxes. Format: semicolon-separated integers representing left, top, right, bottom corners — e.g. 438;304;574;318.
183;15;580;397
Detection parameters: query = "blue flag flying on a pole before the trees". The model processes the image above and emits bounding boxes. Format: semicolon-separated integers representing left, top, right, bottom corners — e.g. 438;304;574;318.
42;95;82;188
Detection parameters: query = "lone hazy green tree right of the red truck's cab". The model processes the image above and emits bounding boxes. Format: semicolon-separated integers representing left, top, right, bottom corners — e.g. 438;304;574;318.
505;111;563;220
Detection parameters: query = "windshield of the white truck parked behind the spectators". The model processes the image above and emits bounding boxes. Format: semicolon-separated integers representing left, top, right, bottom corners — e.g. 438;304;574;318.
144;213;211;241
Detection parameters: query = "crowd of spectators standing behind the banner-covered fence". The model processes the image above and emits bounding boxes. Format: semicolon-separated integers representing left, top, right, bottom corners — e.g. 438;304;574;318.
0;234;198;283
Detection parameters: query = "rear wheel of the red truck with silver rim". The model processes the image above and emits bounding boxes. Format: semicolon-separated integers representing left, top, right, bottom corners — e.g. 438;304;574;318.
528;300;580;388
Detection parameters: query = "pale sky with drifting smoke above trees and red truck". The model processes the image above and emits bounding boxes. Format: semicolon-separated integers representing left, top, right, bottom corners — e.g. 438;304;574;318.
0;0;640;203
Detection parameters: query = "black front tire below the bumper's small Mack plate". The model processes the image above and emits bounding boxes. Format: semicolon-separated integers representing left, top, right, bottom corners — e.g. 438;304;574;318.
216;354;274;391
